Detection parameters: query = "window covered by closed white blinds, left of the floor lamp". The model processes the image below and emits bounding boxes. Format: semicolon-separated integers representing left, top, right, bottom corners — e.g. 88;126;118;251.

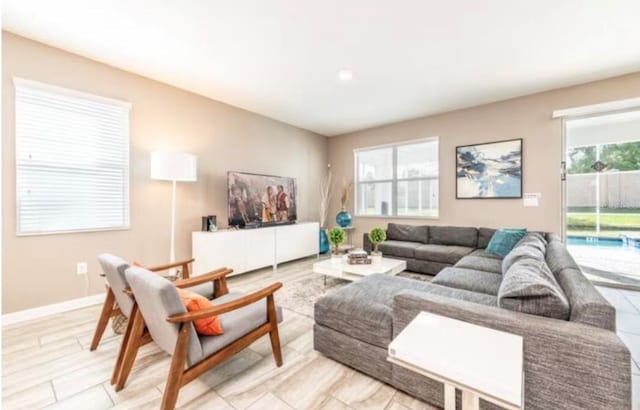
14;78;130;235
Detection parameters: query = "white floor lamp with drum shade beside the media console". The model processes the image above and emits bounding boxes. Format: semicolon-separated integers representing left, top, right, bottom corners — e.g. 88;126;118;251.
151;151;198;274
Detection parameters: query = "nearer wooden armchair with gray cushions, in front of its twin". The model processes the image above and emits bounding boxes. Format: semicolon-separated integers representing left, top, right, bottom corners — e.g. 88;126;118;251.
124;267;282;409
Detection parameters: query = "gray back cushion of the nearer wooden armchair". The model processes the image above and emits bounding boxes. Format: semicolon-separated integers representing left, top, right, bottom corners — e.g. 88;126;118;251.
125;266;202;366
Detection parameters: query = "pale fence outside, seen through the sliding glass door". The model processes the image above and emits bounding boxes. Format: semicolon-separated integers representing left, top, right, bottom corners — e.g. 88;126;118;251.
567;171;640;208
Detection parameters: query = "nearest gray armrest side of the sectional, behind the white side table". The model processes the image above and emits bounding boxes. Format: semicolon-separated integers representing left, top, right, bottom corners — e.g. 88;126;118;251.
393;290;631;410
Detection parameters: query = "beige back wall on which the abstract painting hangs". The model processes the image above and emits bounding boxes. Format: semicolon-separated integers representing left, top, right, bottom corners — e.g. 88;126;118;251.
329;73;640;244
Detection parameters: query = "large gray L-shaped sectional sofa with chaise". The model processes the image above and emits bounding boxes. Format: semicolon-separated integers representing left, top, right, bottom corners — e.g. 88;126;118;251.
314;224;631;410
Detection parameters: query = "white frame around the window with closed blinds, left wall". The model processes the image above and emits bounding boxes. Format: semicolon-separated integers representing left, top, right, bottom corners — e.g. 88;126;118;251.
13;77;132;237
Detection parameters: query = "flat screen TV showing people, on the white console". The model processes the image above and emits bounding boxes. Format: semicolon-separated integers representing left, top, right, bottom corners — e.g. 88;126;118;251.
227;171;297;228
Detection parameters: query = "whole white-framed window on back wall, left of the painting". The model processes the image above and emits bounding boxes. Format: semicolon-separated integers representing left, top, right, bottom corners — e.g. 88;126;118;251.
355;138;438;218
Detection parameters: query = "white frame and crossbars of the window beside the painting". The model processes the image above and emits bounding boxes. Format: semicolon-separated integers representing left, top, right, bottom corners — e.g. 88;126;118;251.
353;136;440;220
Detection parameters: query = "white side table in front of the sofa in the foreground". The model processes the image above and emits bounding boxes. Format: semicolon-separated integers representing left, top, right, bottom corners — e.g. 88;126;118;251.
388;312;524;410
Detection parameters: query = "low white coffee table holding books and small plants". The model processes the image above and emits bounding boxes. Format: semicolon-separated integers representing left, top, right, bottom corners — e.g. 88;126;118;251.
313;257;407;281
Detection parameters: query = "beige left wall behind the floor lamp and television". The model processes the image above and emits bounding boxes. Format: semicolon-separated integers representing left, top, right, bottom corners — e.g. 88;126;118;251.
2;32;327;313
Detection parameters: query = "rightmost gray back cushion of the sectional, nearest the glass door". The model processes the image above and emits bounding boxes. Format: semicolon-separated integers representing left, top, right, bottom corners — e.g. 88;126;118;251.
546;235;616;331
